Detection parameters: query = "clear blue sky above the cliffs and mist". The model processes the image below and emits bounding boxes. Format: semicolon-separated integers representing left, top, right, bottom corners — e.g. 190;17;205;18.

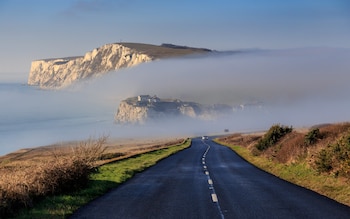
0;0;350;78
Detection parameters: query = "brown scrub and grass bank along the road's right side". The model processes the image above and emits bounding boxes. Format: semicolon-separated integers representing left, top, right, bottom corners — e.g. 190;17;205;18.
217;123;350;206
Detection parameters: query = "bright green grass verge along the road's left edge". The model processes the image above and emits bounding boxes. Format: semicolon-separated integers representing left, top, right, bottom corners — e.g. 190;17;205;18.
15;139;191;219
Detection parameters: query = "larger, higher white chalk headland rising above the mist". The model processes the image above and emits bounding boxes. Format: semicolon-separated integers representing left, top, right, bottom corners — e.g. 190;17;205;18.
28;43;210;89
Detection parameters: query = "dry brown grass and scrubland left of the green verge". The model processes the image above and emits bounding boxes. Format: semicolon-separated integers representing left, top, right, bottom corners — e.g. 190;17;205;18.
0;136;183;218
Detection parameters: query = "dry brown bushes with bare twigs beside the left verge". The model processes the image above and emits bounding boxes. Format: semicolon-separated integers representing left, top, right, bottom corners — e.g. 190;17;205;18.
0;137;107;218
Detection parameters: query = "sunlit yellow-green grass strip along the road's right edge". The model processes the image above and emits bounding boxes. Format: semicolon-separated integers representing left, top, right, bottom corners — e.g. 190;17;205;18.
216;140;350;206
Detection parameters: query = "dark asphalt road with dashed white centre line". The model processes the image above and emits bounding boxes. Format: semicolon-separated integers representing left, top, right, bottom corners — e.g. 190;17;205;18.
71;138;350;219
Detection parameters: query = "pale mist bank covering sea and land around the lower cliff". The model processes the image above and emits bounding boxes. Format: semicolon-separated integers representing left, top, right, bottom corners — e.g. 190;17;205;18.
0;48;350;156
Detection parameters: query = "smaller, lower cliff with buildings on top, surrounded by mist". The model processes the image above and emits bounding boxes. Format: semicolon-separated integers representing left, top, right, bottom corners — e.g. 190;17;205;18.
114;95;232;124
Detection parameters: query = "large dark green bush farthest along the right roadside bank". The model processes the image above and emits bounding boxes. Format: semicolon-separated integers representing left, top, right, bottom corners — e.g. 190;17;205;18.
255;124;293;151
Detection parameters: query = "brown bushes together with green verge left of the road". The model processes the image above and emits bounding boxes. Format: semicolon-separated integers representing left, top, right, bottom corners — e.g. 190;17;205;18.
0;136;190;218
